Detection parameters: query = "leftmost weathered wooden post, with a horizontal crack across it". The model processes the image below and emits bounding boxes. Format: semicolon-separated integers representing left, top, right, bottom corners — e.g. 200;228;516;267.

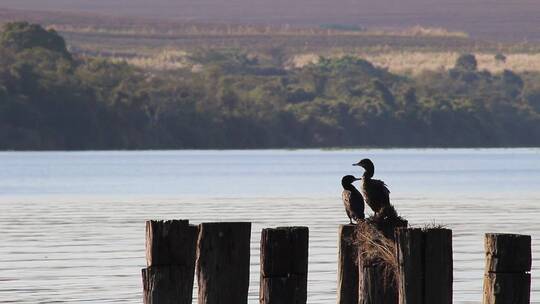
142;220;198;304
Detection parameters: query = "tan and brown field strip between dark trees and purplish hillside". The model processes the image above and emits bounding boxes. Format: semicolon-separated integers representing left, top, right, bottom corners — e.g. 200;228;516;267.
0;9;540;74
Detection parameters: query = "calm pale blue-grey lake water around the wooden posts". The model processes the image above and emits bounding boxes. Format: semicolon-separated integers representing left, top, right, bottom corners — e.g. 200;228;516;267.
0;149;540;304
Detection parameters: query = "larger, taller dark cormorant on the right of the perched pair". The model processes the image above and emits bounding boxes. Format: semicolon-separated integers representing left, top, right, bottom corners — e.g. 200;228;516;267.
353;158;397;219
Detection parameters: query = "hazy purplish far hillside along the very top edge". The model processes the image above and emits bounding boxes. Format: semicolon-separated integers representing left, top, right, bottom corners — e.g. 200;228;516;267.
0;0;540;41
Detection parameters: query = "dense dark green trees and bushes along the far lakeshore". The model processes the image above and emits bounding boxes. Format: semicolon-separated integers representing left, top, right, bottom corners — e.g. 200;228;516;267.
0;23;540;149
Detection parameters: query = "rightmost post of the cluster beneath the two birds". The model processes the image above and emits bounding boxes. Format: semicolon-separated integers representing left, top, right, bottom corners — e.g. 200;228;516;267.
424;228;454;304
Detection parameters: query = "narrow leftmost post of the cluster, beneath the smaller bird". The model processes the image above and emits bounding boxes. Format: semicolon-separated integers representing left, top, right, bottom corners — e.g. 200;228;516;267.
337;224;358;304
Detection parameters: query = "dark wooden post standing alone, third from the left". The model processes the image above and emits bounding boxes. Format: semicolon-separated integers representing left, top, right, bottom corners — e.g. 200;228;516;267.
259;227;309;304
